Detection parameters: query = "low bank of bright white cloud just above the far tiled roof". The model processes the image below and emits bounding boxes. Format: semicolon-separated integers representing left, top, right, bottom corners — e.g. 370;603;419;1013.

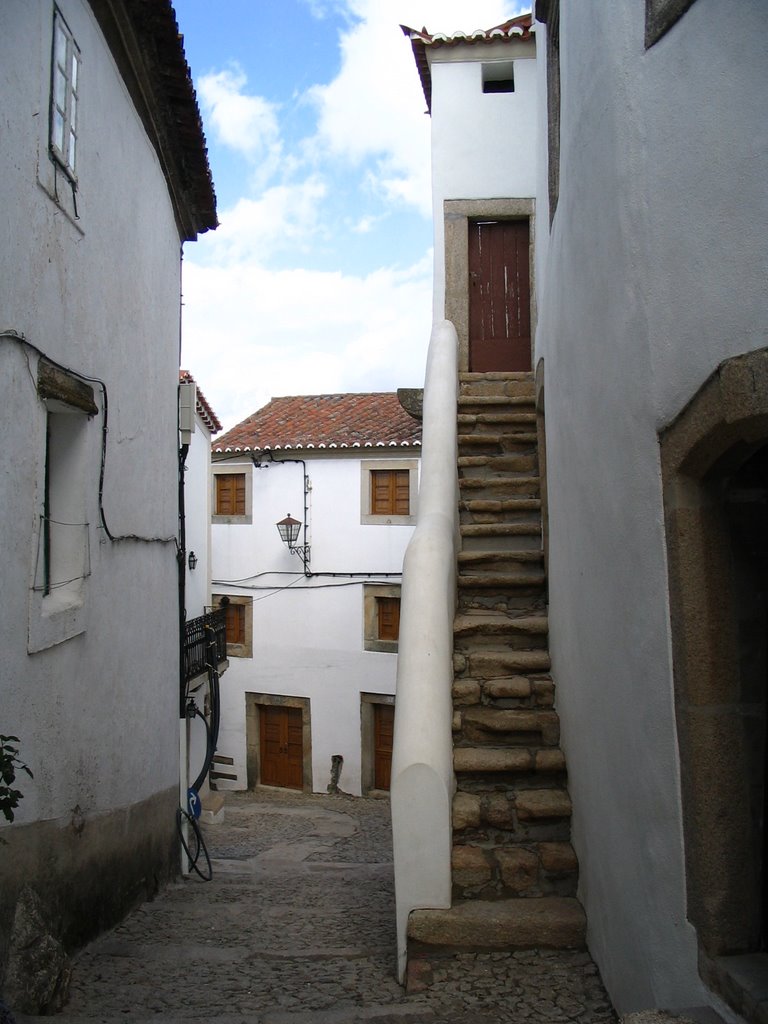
182;257;432;428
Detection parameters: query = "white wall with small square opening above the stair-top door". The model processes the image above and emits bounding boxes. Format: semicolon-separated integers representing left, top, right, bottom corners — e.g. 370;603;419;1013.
427;39;538;322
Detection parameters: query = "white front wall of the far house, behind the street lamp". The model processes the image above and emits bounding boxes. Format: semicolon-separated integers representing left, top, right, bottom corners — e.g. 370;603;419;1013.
212;447;420;795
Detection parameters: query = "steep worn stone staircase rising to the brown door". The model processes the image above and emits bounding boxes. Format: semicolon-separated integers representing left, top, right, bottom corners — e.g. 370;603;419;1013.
409;373;586;977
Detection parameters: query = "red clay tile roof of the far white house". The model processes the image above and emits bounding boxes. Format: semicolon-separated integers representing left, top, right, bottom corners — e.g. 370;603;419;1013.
213;391;421;452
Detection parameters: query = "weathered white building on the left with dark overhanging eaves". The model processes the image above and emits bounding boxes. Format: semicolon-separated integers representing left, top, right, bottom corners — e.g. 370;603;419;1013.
0;0;216;1013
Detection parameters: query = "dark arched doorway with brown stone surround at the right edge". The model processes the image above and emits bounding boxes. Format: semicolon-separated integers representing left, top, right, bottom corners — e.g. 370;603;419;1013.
660;349;768;1017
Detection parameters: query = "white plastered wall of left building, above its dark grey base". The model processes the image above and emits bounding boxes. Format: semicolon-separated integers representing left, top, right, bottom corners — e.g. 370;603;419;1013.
0;0;179;827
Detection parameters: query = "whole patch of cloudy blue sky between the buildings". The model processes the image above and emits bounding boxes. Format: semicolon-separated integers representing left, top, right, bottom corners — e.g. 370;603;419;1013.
174;0;523;428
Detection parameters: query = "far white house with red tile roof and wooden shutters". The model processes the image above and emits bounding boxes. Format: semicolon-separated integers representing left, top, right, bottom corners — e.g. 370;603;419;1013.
212;393;421;794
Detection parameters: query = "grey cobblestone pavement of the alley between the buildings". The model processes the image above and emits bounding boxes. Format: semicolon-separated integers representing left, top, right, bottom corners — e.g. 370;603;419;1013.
17;790;615;1024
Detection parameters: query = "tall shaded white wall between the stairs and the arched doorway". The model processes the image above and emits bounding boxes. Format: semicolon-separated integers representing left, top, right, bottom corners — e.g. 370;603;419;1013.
537;0;768;1012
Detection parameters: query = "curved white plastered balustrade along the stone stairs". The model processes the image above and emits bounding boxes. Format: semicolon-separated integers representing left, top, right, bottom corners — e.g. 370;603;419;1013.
390;321;459;981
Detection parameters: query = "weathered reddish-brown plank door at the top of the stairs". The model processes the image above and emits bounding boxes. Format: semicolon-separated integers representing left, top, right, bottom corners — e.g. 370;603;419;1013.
469;220;530;373
